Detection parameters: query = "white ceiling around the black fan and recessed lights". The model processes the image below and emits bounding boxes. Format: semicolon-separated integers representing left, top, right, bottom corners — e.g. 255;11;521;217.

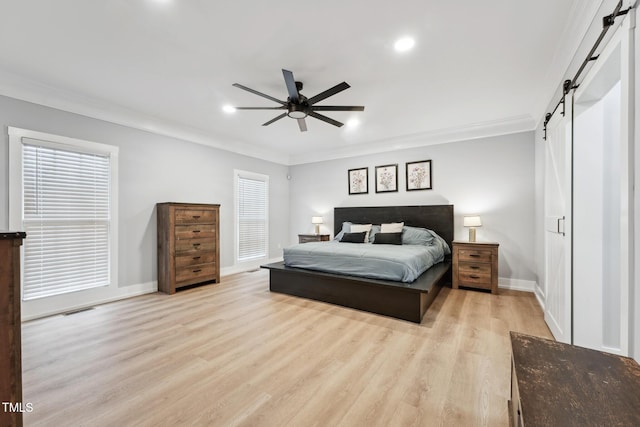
0;0;600;164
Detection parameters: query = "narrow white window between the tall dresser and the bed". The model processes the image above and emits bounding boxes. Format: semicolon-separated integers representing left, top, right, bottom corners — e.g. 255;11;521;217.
235;171;269;262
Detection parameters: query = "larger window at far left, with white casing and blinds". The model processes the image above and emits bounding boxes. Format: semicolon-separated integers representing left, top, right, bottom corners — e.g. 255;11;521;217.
9;127;118;318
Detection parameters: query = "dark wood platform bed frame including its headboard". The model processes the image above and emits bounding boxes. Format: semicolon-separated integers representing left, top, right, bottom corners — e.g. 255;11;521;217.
262;205;453;323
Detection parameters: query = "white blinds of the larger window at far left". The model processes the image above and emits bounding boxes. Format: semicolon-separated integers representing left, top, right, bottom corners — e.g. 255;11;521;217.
22;139;110;300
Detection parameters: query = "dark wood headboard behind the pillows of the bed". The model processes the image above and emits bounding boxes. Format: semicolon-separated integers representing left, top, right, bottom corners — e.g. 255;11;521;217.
333;205;453;247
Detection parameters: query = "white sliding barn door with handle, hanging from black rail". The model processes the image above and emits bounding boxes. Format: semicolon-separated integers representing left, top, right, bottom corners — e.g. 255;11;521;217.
544;101;572;343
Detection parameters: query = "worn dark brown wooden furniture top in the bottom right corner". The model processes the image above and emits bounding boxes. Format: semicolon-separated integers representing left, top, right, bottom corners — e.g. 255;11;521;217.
509;332;640;427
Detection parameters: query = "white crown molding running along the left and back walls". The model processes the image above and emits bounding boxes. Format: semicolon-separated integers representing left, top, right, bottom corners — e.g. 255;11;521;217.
0;70;535;166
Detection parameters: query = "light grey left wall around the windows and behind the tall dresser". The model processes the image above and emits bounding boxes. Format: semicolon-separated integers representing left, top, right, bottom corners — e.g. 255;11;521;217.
0;96;289;287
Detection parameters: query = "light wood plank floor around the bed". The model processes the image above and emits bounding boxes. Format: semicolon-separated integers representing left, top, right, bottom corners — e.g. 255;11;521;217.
23;270;551;426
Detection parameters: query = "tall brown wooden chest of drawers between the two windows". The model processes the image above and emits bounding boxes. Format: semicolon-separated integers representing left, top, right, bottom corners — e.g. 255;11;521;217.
157;203;220;294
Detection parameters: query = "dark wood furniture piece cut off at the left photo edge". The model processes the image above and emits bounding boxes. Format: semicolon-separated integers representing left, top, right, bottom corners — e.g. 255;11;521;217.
0;232;26;426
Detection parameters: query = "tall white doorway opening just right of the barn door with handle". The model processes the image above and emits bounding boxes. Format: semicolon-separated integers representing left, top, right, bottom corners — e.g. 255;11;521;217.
573;20;633;356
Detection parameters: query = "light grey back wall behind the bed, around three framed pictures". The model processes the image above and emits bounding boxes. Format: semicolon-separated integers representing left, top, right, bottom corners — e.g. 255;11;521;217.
289;132;536;290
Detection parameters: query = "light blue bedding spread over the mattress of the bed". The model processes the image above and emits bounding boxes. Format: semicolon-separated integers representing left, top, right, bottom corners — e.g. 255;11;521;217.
284;233;450;283
